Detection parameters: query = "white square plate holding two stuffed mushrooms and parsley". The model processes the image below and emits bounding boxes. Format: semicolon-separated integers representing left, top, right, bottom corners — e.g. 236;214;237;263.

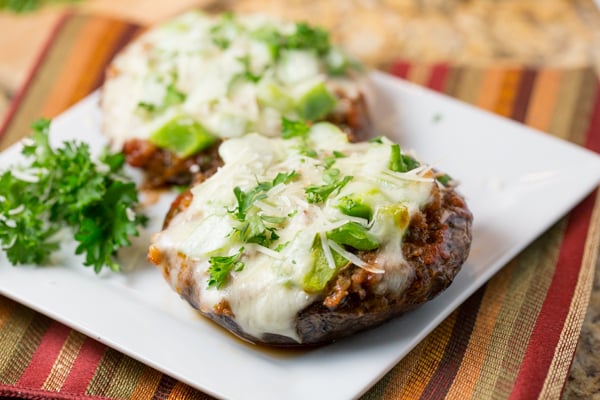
0;72;600;400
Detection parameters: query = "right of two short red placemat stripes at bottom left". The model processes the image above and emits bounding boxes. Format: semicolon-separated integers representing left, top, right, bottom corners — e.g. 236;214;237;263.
61;338;107;393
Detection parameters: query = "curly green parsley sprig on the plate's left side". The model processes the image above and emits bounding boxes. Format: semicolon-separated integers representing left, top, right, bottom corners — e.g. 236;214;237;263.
0;119;146;272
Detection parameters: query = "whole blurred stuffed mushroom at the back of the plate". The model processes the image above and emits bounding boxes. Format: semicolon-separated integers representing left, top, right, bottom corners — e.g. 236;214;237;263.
101;12;369;187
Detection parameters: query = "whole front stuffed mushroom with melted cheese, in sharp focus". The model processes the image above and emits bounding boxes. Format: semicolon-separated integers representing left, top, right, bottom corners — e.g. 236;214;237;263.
148;120;472;346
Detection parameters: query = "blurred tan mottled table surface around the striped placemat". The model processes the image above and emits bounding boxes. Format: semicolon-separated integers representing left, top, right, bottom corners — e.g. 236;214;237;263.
0;0;600;399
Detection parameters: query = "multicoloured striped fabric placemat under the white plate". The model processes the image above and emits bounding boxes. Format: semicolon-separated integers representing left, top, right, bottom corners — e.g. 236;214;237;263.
0;15;600;399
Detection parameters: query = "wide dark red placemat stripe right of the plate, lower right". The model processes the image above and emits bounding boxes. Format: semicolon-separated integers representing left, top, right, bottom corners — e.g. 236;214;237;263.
510;194;596;399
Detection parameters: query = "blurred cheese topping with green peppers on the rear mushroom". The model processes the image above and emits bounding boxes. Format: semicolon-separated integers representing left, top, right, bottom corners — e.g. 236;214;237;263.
103;12;360;155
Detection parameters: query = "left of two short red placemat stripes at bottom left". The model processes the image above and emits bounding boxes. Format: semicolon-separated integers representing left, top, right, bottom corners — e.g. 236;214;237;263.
17;322;71;388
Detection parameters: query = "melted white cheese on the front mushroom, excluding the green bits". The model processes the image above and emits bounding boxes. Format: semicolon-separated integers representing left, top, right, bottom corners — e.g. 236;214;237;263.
153;123;436;340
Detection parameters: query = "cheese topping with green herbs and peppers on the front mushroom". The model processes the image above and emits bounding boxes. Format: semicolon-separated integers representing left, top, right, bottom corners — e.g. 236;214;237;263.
153;123;436;340
